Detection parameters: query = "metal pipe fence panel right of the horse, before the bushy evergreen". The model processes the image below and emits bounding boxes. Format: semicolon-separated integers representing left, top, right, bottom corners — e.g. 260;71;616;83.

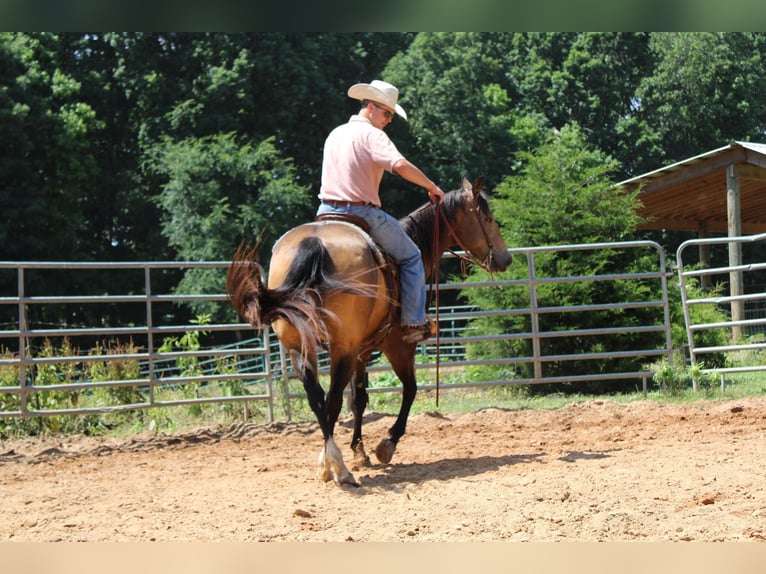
281;241;672;408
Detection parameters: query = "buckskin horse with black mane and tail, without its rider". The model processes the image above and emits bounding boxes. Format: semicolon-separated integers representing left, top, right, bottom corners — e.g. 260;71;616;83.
226;178;511;486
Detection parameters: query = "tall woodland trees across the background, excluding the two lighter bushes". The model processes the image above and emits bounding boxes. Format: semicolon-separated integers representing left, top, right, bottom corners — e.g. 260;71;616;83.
0;32;766;270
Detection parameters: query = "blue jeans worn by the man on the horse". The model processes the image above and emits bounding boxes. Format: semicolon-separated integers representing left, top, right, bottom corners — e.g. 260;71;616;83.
317;203;426;325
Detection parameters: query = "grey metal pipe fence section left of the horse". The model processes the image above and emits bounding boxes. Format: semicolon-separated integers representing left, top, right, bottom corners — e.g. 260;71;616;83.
0;261;274;420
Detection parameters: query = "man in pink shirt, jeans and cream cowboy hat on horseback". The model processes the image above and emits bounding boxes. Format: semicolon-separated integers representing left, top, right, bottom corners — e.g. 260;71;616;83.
317;80;444;343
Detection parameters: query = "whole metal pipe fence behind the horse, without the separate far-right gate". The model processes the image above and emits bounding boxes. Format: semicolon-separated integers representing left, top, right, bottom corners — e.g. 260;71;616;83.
0;241;671;420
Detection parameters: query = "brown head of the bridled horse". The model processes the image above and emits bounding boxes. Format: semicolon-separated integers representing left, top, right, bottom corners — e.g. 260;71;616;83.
450;178;511;271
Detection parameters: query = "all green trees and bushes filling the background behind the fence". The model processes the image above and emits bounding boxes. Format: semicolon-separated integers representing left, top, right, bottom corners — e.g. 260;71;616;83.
0;32;766;408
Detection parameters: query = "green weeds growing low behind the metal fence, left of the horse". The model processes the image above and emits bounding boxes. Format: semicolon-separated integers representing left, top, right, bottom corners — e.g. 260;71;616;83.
0;315;265;439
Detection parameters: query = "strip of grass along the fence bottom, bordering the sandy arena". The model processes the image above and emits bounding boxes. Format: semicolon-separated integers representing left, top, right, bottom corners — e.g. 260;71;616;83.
0;358;766;439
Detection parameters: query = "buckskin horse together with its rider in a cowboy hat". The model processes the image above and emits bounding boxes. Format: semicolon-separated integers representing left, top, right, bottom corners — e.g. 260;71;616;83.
226;80;510;486
